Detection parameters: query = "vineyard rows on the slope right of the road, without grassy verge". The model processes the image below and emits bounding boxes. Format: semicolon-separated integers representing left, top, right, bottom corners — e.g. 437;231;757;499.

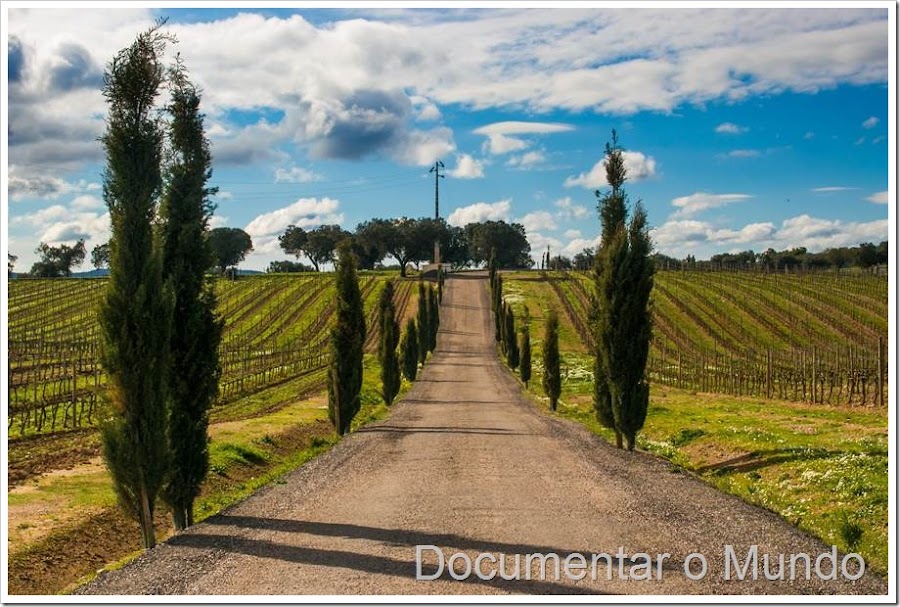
546;271;888;405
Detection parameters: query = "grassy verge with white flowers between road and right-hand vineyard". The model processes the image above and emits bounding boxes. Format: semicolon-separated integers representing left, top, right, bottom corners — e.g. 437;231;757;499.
504;277;888;573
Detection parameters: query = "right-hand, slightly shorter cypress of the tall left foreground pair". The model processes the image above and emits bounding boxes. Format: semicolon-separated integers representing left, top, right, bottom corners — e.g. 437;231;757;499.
161;61;222;531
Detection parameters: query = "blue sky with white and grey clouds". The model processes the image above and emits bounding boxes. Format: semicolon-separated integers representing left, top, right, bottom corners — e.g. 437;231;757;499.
3;3;896;271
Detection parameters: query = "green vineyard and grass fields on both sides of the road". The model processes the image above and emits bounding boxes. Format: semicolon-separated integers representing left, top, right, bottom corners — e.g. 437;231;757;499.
7;272;888;593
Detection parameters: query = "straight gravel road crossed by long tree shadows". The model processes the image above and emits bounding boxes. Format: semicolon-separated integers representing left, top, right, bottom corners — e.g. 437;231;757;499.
78;275;887;595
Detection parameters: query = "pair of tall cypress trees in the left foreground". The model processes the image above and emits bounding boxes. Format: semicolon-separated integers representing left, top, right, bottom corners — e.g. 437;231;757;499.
99;23;222;548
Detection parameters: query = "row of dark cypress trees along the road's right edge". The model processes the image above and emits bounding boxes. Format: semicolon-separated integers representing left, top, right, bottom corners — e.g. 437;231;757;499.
488;131;654;451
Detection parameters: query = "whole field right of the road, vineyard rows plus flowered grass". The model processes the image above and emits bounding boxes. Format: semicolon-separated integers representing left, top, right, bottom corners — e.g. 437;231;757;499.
503;272;888;572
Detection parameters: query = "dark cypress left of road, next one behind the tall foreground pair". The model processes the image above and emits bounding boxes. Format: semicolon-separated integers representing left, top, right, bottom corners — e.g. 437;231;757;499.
328;241;366;435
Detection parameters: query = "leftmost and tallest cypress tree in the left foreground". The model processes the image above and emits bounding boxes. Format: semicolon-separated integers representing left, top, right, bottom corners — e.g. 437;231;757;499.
99;26;173;548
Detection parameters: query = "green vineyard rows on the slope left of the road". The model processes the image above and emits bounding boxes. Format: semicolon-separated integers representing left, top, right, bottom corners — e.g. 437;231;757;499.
7;274;415;436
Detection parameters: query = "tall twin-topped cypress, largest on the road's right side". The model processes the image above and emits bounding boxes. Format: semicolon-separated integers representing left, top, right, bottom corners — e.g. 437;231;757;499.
592;131;654;451
